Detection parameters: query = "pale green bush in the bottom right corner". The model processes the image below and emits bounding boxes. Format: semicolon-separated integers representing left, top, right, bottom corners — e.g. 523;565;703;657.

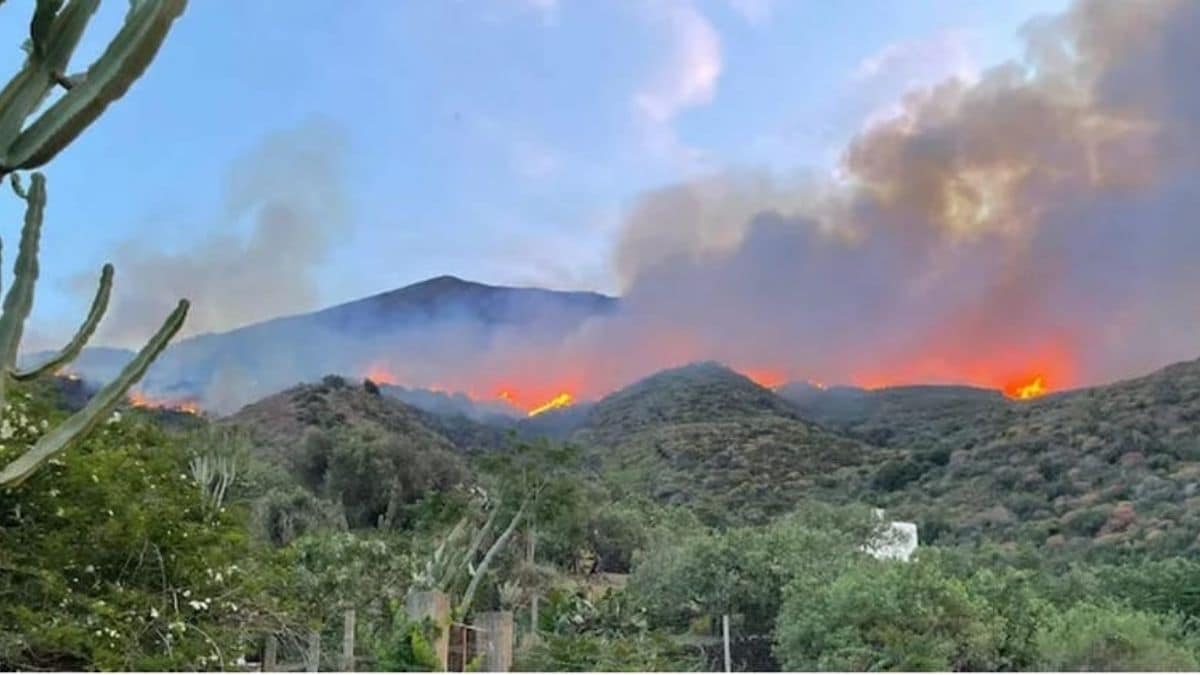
1038;604;1200;671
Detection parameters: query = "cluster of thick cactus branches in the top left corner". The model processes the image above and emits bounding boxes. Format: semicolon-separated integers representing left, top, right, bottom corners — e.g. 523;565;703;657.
0;0;187;175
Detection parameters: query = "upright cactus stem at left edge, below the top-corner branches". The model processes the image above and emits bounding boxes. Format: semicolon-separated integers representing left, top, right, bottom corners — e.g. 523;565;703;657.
0;173;46;384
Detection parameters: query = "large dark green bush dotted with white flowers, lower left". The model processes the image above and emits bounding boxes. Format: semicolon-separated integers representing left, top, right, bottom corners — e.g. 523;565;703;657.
0;393;283;670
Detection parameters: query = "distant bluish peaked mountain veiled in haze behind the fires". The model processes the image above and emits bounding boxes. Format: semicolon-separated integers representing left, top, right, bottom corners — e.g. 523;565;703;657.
35;276;617;413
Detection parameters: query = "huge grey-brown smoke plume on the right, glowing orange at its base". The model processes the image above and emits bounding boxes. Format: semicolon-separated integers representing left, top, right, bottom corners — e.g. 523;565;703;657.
604;0;1200;388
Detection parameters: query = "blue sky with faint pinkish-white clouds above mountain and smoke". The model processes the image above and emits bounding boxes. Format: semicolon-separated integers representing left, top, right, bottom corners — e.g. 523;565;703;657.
0;0;1064;339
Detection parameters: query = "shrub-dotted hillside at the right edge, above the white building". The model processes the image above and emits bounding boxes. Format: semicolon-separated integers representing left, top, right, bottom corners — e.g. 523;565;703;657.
830;360;1200;555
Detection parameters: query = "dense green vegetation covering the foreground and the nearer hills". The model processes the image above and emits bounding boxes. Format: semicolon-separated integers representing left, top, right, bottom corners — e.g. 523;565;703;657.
7;364;1200;670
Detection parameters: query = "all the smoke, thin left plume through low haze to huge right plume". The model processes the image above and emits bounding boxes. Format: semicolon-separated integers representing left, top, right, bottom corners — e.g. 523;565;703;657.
93;0;1200;410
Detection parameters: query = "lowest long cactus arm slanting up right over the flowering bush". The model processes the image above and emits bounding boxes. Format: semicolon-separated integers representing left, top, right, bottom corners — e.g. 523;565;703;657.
0;300;188;486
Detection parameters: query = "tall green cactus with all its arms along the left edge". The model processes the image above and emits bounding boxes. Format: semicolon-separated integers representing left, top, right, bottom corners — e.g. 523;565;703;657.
0;0;188;486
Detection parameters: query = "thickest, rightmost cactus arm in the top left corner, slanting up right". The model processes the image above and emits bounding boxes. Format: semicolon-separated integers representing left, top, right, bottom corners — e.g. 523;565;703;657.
0;0;186;171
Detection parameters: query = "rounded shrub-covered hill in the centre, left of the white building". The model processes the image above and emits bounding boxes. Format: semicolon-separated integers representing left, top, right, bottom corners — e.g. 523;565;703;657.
571;363;895;524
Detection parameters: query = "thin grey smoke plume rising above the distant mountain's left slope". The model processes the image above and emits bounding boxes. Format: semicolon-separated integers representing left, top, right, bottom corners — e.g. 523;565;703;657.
87;123;350;346
